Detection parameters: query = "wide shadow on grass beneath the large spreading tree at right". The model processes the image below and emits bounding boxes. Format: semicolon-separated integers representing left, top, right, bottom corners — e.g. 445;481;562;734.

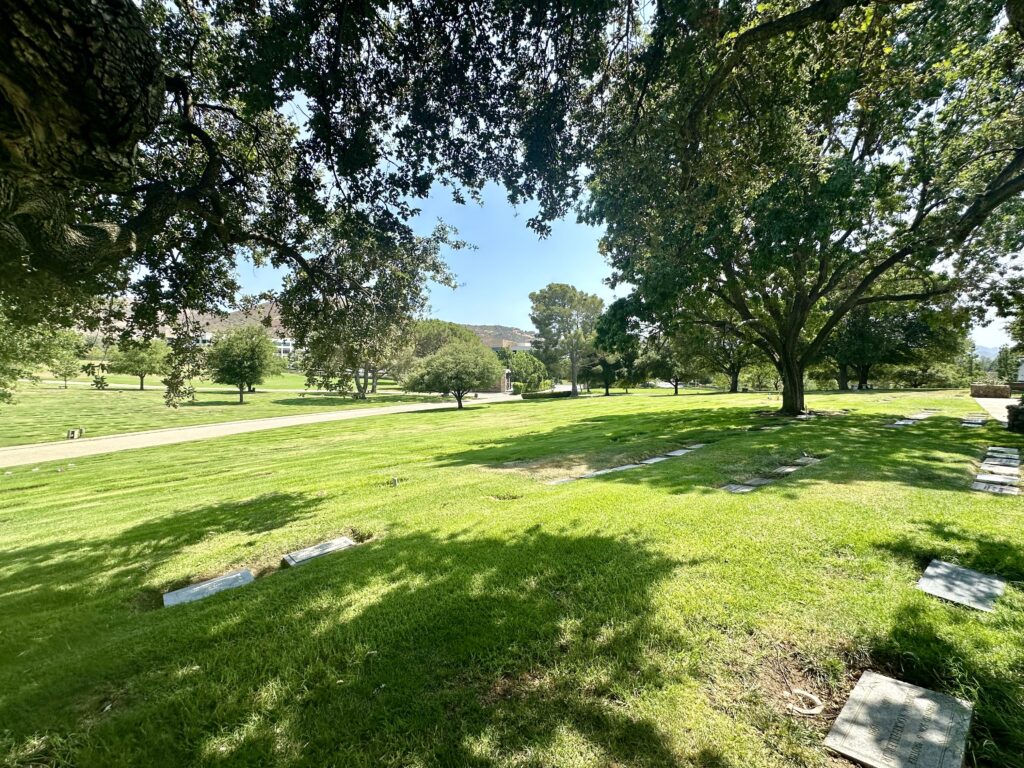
430;406;1013;493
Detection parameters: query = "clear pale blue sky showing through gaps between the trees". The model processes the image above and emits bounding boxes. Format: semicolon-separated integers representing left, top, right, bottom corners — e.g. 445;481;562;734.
239;186;1007;347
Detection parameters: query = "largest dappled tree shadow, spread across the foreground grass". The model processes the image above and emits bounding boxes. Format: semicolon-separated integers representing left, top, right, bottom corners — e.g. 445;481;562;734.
0;529;729;768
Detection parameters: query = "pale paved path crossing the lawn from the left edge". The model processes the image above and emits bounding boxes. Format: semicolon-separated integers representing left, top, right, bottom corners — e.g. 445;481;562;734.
0;394;519;467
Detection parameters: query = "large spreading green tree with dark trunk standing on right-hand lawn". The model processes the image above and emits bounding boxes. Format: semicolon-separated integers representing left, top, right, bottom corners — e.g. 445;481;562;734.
585;0;1024;414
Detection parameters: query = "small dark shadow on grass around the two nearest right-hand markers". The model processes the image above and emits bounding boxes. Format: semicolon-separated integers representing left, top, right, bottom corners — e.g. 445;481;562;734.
870;520;1024;768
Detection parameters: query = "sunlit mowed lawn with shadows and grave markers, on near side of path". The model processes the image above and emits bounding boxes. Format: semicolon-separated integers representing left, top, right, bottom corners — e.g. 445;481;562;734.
0;392;1024;768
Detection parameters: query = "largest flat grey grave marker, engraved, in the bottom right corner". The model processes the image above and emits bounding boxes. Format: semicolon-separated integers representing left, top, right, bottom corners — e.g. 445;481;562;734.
825;672;974;768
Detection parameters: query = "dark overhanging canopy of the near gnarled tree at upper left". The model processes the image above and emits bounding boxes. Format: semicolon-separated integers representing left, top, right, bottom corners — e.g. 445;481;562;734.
0;0;623;354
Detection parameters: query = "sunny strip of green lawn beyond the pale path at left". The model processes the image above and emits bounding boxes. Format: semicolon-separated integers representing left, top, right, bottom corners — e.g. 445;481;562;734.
0;384;443;446
